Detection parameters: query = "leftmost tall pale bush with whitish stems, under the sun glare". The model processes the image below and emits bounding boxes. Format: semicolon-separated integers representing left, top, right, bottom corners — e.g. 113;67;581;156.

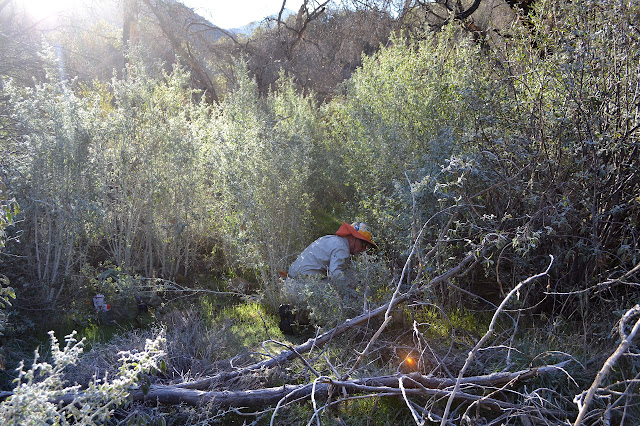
4;51;101;302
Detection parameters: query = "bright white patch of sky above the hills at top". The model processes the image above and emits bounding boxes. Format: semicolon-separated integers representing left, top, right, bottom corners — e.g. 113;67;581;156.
182;0;302;28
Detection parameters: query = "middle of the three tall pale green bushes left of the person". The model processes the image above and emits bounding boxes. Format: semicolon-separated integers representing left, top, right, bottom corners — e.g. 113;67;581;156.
94;60;207;278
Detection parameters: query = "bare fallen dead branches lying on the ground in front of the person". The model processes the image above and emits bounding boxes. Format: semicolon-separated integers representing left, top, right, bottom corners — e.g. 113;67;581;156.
5;253;584;423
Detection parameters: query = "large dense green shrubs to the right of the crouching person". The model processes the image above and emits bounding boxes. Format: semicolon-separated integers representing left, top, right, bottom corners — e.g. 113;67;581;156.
322;1;640;320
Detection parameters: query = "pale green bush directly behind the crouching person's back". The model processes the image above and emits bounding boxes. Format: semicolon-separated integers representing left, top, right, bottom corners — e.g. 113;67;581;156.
203;64;317;306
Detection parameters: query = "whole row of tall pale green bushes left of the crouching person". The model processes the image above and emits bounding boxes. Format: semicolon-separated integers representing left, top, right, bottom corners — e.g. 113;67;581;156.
7;48;319;310
